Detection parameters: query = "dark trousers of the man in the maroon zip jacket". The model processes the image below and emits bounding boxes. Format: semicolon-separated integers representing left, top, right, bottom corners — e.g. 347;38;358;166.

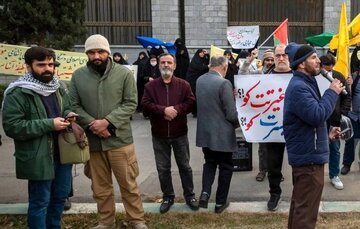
152;135;195;201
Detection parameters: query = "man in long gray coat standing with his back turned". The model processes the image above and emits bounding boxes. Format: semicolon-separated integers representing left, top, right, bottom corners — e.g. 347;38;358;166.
196;56;239;213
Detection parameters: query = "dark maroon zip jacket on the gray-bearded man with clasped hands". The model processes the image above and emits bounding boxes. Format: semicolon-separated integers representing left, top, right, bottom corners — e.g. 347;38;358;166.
141;76;195;138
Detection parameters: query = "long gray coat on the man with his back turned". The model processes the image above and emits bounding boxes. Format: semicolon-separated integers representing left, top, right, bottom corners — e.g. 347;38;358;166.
196;70;238;151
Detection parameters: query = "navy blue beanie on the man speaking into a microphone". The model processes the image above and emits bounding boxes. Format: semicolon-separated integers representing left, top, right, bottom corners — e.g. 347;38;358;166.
285;42;316;70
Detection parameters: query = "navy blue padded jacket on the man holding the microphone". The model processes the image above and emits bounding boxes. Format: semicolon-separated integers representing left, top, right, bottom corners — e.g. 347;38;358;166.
283;71;338;166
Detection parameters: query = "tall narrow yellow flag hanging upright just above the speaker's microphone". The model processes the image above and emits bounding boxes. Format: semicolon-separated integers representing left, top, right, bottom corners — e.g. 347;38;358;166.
334;2;349;78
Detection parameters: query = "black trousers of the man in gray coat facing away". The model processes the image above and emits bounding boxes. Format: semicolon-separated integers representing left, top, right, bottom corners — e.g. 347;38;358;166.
202;147;233;204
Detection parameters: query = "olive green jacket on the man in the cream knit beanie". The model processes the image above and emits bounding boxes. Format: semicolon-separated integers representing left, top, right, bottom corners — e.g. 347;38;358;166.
69;59;137;152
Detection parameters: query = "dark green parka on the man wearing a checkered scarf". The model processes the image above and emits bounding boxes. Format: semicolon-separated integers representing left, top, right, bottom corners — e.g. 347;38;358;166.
2;87;70;180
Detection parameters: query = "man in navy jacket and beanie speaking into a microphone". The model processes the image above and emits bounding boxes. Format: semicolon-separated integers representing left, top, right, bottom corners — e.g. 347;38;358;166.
283;43;344;228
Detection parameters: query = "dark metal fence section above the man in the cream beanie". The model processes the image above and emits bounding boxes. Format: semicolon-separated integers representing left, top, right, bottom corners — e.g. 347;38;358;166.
84;0;152;45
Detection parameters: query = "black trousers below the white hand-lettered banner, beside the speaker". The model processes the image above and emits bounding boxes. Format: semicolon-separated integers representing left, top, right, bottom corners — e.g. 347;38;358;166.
260;142;285;195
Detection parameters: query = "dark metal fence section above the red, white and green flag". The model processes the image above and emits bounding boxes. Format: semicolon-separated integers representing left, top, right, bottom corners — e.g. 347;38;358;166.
228;0;324;46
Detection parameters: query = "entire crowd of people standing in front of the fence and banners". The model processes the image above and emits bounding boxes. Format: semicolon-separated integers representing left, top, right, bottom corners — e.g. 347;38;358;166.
0;34;360;229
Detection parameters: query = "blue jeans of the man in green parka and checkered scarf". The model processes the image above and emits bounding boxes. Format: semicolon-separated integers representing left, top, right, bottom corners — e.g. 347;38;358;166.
27;161;72;229
